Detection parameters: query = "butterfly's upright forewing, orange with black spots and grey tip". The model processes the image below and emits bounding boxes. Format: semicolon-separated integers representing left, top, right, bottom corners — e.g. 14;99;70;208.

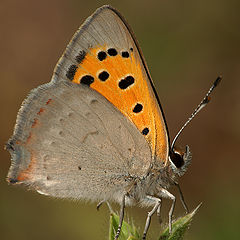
55;6;169;163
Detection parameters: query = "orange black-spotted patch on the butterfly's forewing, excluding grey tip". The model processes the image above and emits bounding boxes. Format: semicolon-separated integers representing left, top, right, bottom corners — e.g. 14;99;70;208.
66;46;167;161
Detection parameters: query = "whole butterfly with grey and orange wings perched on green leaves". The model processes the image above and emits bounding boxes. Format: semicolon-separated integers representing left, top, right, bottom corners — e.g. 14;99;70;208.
6;5;221;239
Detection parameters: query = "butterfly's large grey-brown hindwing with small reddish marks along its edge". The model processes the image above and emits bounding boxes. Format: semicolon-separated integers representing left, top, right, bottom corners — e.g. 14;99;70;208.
7;81;151;200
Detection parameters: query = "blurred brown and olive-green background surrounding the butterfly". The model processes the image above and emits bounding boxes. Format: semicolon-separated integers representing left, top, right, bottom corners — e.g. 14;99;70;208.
0;0;240;240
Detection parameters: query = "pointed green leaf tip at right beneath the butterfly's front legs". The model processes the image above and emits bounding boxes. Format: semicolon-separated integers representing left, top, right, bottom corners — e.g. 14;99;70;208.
159;204;201;240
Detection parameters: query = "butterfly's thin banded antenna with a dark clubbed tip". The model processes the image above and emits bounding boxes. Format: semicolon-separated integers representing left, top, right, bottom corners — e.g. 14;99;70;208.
171;76;222;150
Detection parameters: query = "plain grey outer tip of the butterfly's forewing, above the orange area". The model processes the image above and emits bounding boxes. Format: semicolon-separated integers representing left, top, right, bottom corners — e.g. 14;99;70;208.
53;5;144;83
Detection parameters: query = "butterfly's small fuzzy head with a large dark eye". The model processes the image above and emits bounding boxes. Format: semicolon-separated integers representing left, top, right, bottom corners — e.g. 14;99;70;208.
169;146;192;177
